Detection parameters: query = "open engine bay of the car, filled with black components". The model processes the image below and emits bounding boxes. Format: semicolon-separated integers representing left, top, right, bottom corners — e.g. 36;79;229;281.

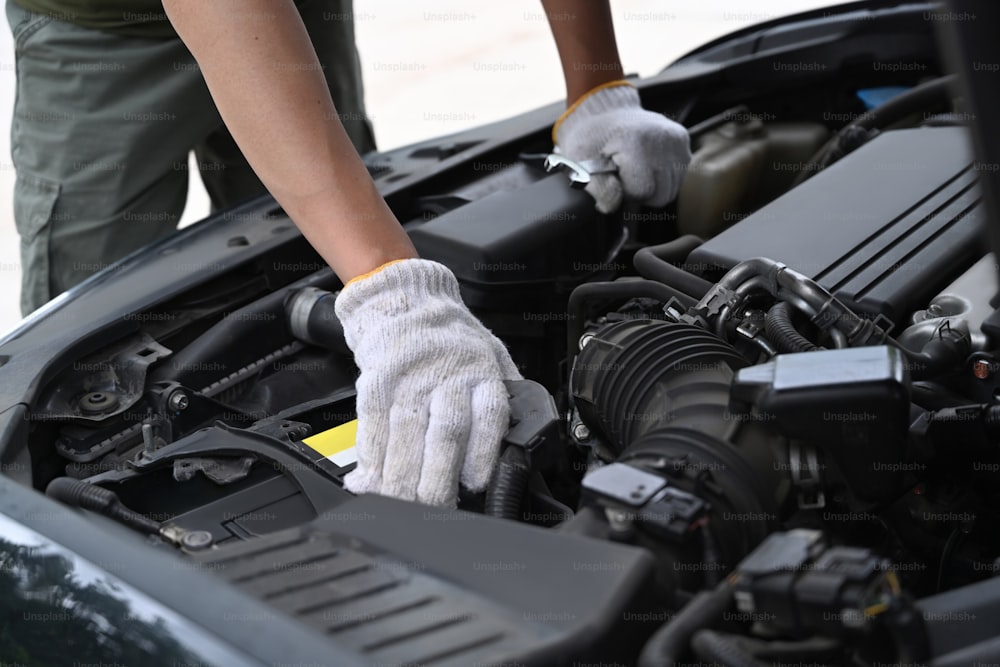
3;3;1000;667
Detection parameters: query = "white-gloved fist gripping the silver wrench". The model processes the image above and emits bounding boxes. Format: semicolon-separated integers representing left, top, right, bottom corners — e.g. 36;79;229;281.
552;81;691;213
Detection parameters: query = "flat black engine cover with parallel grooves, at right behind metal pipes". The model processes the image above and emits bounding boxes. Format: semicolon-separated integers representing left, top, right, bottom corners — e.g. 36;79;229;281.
688;127;986;324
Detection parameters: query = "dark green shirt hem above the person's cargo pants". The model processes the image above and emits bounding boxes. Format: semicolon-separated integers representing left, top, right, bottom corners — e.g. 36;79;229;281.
14;0;177;38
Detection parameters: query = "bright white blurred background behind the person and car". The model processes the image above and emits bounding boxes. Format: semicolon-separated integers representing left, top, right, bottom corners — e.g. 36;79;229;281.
0;0;841;332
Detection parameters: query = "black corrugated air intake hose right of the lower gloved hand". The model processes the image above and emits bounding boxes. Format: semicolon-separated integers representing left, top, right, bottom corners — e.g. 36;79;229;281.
570;320;791;563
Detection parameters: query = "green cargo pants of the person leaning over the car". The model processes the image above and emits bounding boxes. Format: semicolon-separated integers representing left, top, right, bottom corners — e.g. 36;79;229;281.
7;0;374;315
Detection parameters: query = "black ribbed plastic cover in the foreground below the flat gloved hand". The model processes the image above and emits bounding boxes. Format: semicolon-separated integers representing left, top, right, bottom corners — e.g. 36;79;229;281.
195;496;662;667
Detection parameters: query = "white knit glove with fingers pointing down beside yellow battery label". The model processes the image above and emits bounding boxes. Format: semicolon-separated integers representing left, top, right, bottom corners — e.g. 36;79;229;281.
336;259;521;507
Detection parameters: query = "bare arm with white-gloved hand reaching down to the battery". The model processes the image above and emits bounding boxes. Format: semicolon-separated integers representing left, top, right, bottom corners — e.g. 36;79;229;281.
163;0;520;505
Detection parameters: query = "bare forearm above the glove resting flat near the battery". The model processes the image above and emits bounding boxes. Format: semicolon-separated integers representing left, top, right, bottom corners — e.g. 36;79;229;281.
163;0;416;282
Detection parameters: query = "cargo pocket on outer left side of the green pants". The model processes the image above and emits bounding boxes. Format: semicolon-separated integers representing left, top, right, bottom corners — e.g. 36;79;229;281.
14;174;59;315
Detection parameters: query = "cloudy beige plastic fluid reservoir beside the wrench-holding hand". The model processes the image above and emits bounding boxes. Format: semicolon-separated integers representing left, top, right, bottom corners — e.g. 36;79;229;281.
677;118;829;238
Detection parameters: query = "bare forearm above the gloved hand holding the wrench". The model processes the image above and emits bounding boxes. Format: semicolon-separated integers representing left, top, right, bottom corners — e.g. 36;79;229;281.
541;0;623;105
